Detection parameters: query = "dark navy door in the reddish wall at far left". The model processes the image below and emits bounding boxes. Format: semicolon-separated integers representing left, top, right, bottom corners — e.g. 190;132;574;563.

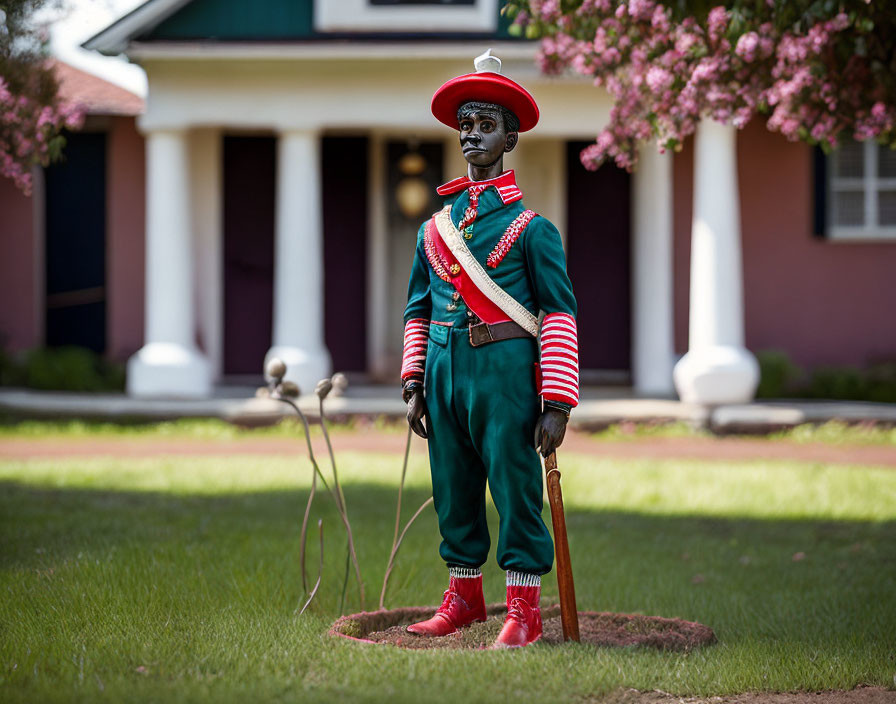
43;132;106;353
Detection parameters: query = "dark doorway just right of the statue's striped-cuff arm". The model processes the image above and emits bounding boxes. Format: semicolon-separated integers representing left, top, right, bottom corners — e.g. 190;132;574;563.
566;142;631;382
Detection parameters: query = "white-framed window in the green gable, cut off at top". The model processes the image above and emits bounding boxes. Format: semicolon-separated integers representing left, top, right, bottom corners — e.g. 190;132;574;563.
314;0;498;34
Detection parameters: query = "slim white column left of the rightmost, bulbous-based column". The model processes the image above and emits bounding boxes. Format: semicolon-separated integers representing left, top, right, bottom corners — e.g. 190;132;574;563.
632;143;675;396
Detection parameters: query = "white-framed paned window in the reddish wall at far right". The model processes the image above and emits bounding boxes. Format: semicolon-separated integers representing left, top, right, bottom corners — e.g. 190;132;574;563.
827;140;896;239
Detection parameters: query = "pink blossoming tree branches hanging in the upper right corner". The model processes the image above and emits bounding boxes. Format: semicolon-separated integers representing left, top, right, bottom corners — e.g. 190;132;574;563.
504;0;896;170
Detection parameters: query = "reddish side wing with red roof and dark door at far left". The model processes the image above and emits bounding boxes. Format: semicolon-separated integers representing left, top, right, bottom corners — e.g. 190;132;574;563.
0;62;146;360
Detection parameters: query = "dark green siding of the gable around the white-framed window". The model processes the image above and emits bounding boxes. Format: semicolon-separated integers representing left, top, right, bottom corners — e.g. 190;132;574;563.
135;0;516;41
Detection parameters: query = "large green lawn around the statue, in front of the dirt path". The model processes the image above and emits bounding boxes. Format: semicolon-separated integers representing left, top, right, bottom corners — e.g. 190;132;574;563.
0;434;896;703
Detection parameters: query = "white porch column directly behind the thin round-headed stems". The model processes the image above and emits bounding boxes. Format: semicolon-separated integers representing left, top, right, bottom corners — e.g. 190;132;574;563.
265;130;334;393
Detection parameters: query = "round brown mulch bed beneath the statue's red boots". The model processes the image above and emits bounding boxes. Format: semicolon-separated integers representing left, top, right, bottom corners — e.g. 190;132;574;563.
329;604;716;650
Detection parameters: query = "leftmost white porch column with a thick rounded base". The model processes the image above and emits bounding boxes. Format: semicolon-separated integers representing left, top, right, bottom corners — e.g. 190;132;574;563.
127;130;211;397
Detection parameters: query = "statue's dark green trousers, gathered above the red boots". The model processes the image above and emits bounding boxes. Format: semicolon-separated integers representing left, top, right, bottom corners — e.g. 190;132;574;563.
424;324;554;574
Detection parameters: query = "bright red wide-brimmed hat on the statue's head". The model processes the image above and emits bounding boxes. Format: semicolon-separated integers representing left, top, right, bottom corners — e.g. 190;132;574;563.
432;71;538;132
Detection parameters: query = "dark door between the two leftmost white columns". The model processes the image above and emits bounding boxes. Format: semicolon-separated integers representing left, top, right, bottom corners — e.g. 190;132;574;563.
223;136;277;375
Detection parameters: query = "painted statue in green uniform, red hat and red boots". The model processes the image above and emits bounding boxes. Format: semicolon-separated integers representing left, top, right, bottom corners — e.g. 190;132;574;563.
401;52;579;647
